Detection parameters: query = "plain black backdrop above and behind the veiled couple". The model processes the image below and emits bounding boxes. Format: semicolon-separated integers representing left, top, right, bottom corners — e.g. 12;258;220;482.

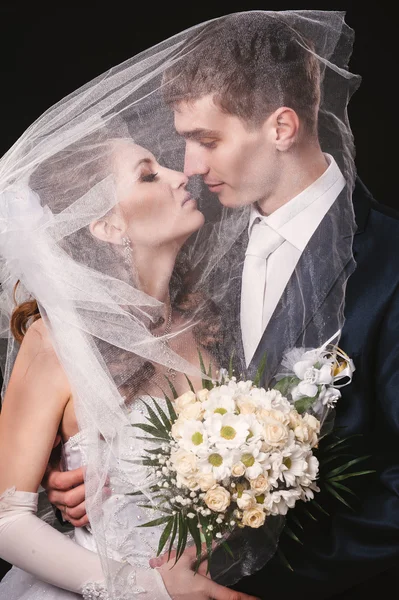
0;0;399;598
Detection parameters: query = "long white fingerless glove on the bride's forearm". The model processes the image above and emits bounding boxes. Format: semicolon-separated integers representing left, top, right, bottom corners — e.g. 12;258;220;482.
0;489;170;600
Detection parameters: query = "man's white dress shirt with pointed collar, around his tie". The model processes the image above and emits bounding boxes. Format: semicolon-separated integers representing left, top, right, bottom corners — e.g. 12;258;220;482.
241;154;345;365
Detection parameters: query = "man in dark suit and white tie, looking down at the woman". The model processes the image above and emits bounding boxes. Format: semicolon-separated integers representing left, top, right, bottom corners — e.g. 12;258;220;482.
43;10;399;600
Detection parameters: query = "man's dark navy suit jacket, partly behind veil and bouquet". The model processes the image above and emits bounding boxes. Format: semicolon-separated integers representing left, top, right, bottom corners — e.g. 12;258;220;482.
220;180;399;600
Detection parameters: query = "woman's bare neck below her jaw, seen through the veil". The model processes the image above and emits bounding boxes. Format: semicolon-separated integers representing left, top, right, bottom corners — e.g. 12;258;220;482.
134;243;179;302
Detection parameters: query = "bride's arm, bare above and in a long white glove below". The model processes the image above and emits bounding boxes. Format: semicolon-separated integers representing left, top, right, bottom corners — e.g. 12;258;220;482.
0;321;169;600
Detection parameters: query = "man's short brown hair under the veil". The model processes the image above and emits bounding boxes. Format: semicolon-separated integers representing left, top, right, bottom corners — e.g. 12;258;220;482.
163;12;320;133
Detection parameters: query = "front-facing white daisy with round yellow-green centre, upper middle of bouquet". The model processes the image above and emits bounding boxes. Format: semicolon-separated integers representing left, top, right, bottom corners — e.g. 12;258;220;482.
204;413;249;449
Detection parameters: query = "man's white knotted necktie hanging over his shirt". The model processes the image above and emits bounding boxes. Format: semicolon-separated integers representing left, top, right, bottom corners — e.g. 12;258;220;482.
241;221;284;365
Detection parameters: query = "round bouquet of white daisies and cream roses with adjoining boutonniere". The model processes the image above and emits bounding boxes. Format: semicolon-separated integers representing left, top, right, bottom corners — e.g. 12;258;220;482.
134;340;366;567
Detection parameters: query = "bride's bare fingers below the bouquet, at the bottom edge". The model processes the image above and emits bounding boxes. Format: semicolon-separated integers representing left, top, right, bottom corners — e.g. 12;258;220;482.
150;546;259;600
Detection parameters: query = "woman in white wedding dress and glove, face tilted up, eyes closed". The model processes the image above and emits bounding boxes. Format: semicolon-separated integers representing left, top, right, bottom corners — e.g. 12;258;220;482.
0;117;256;600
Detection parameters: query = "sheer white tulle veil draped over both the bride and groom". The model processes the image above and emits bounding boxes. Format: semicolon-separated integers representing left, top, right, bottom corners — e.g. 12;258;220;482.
0;11;358;598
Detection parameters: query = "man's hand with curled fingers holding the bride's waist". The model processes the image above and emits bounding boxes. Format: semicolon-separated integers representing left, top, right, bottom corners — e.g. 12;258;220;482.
42;464;89;527
